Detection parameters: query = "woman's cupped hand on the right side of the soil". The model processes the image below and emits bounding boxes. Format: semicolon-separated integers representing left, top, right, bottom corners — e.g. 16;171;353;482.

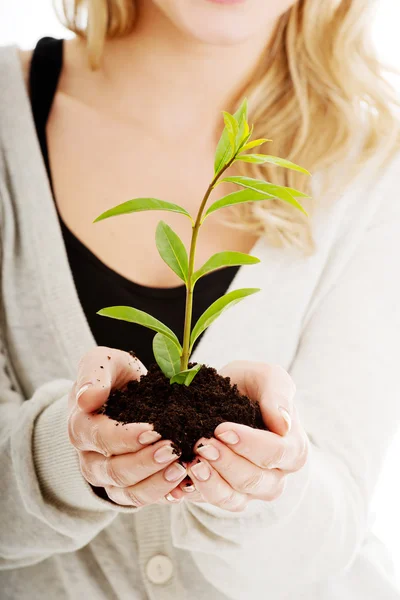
172;361;309;511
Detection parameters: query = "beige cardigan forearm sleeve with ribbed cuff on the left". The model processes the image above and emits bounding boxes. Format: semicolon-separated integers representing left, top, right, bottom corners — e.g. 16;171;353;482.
0;338;136;569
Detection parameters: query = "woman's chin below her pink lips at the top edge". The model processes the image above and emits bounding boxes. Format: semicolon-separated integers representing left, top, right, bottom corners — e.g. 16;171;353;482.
153;0;296;46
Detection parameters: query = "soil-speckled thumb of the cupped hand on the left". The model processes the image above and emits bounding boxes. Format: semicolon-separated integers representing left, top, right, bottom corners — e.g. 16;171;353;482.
73;346;146;412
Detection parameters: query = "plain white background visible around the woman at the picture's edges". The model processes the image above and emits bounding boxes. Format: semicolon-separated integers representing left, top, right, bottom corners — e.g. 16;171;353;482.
0;0;400;584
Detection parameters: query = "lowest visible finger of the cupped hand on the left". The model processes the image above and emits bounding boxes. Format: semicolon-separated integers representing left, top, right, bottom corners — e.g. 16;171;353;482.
105;463;187;508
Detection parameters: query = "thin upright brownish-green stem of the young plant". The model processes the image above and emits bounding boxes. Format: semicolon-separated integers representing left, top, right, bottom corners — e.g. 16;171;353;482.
181;161;235;371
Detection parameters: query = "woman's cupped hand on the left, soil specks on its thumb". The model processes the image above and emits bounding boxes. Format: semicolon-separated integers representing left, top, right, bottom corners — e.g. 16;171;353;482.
68;347;187;506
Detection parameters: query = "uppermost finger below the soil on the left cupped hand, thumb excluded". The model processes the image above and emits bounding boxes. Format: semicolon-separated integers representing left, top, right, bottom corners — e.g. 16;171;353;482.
68;405;161;456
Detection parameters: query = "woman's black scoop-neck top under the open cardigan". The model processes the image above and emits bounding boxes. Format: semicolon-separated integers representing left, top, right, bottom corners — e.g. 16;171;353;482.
29;37;238;366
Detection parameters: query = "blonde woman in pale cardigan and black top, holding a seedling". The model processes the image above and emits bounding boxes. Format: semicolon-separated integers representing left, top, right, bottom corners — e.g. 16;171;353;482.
0;0;400;600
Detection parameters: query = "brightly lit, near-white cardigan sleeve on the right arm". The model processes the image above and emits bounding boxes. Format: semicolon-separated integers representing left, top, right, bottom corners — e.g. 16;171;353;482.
172;180;400;600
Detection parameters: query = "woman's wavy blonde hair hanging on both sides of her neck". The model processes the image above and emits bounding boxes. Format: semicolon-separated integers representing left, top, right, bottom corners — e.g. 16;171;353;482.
56;0;400;251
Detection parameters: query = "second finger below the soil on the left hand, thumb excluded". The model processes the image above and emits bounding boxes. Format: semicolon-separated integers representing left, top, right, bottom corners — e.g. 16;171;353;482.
80;441;181;488
